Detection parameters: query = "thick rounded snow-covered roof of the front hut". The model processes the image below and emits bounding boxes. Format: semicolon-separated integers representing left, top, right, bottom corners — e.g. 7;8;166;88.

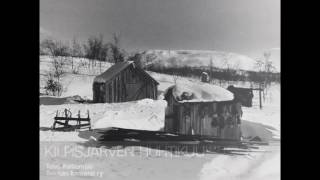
167;82;234;103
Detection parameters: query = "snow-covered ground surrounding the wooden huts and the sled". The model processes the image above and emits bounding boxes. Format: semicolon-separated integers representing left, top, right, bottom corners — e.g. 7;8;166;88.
39;57;280;180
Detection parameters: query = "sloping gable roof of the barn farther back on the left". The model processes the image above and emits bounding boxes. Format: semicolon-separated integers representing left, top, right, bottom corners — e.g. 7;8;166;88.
94;61;159;84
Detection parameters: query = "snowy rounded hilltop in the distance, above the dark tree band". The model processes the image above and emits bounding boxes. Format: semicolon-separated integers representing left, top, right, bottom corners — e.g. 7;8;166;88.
146;50;280;71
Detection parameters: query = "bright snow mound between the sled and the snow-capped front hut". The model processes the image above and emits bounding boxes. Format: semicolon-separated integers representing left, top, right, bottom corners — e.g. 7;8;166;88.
92;99;167;130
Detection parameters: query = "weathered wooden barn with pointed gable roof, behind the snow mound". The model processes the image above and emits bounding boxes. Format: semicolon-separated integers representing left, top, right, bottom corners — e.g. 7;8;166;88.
93;61;159;103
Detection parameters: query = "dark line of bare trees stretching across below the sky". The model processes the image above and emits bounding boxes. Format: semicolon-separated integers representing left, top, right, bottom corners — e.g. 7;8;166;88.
40;34;280;86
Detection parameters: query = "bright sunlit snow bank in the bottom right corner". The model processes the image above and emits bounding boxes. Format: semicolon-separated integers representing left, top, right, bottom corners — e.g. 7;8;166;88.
200;148;280;180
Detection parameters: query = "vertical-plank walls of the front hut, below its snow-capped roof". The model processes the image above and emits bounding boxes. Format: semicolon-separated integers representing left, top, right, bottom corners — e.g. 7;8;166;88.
164;90;242;140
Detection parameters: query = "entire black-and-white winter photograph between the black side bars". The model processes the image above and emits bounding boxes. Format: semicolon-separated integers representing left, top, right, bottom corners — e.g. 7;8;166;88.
39;0;281;180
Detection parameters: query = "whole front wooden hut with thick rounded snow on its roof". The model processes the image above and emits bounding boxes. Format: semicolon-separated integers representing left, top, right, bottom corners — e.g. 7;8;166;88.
164;83;242;140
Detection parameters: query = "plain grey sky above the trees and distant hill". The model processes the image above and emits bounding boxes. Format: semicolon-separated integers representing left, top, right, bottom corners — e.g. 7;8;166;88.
40;0;280;60
